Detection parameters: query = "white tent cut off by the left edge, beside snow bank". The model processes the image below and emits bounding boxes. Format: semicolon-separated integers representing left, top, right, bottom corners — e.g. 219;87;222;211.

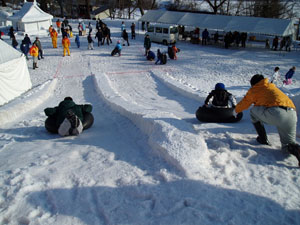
0;40;32;105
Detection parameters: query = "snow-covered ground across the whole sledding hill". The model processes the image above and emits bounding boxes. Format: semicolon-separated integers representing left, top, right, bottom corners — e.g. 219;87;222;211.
0;20;300;225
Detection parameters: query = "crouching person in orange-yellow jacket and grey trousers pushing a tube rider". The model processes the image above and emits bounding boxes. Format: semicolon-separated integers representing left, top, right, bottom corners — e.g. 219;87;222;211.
235;74;300;166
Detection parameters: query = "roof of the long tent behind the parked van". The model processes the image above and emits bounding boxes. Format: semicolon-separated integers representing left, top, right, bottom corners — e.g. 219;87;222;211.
139;10;294;36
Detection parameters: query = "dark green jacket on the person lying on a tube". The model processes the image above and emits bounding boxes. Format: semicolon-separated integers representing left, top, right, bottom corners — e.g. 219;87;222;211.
44;100;93;126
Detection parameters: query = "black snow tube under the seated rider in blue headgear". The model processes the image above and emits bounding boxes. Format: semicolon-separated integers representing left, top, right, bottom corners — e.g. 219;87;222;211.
196;107;243;123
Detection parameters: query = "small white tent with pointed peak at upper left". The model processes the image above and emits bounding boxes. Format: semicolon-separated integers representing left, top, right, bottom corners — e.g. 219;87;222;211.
8;0;53;35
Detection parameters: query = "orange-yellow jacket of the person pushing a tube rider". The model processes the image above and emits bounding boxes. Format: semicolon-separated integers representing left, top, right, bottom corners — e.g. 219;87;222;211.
235;78;296;113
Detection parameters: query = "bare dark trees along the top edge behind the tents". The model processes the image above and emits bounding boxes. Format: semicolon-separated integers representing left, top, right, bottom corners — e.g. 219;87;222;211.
1;0;300;19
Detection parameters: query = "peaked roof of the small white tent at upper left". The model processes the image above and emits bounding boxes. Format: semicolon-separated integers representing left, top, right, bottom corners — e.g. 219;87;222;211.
7;2;53;22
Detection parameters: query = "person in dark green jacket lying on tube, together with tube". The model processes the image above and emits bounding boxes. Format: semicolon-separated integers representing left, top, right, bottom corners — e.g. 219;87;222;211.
44;97;94;136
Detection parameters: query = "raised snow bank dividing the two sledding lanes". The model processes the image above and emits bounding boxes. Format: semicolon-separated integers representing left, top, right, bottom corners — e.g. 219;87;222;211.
95;73;208;178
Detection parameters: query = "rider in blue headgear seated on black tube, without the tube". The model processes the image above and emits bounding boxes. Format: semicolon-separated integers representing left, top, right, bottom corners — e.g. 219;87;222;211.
204;83;236;108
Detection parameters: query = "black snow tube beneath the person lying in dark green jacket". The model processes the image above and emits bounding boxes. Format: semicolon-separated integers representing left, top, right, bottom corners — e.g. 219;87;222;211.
45;112;94;134
